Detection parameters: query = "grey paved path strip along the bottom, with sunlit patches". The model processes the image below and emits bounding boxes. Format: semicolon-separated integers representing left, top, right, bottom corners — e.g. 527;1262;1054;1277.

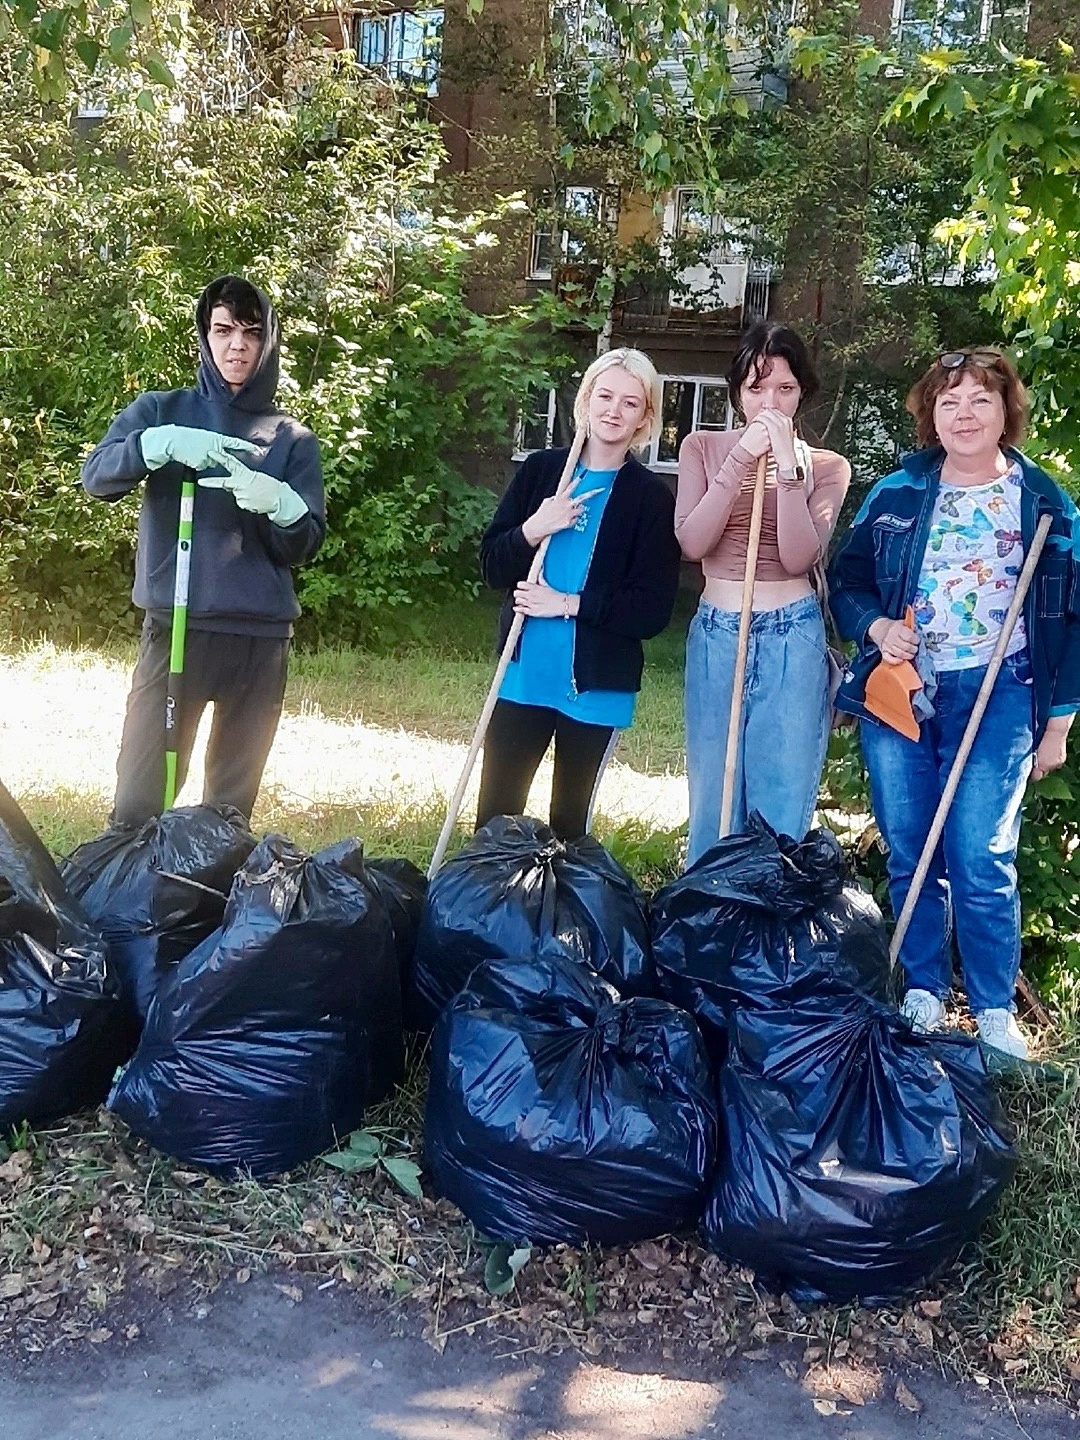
0;1277;1079;1440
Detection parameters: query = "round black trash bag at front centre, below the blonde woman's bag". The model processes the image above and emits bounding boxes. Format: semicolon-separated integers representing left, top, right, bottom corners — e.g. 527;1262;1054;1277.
425;955;716;1244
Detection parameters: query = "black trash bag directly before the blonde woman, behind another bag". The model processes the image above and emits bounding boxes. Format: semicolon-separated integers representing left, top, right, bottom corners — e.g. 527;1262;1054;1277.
413;815;655;1028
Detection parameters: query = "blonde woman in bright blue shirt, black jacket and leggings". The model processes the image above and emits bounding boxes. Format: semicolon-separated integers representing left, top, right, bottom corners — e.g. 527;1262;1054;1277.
477;350;680;840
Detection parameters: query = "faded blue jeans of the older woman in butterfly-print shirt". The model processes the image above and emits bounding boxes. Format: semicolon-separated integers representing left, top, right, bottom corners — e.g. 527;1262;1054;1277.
861;651;1034;1014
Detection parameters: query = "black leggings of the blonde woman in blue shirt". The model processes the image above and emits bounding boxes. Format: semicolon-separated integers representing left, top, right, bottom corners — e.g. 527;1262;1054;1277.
477;700;615;840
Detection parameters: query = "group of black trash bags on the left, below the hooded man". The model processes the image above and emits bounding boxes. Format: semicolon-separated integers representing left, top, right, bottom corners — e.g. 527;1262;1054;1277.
0;786;426;1176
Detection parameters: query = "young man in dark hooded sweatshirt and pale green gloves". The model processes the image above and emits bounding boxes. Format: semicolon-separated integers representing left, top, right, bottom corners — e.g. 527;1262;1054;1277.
82;275;325;825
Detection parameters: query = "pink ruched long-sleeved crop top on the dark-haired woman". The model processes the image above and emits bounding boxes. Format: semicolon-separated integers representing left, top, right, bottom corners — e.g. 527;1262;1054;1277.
675;429;851;580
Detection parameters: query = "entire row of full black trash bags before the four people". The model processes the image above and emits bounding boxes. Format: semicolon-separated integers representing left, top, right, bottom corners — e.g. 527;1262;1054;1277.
0;786;1017;1302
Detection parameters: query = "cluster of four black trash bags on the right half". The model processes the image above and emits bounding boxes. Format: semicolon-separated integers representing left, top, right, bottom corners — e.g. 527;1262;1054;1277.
426;818;1015;1302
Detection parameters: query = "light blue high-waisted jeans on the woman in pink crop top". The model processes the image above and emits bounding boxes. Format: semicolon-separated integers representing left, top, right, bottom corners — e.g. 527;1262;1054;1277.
685;595;831;864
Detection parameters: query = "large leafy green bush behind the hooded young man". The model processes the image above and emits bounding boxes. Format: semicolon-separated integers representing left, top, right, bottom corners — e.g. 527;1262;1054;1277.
0;14;558;636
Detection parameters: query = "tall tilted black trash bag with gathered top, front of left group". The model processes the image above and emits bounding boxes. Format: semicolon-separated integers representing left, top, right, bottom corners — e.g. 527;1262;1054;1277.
109;835;402;1176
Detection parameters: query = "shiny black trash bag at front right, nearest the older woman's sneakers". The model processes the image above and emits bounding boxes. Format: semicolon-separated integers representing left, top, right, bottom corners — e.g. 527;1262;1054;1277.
704;996;1017;1305
